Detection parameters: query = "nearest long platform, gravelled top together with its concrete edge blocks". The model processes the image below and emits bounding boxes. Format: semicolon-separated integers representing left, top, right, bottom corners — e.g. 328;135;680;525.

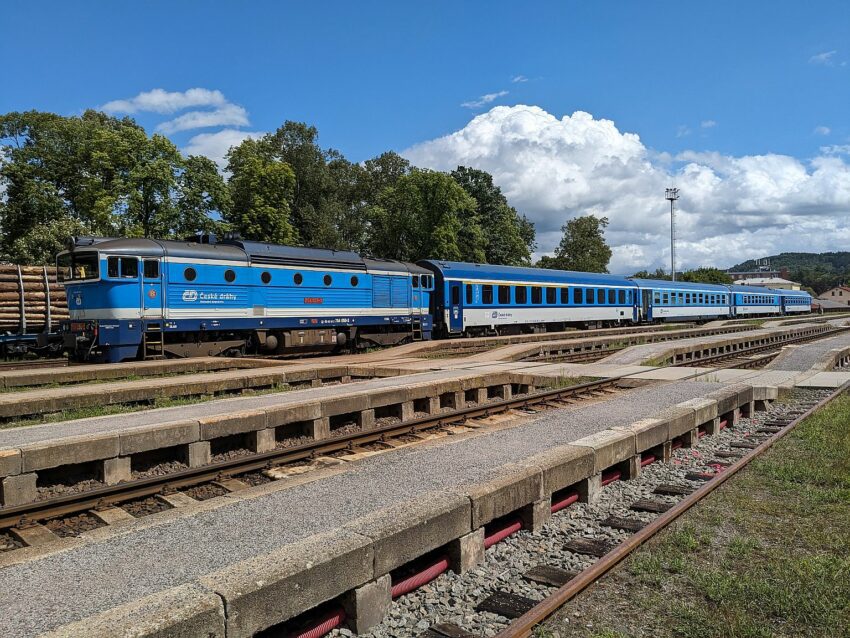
0;382;753;638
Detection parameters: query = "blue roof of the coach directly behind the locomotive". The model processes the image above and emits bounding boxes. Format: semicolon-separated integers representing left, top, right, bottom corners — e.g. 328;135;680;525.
417;259;634;288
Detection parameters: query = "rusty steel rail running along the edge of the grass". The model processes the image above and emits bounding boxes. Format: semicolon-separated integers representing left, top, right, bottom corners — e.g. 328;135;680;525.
496;381;850;638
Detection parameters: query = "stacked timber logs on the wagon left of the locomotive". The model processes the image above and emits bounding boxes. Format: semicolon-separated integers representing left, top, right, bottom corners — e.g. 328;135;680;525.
0;264;68;334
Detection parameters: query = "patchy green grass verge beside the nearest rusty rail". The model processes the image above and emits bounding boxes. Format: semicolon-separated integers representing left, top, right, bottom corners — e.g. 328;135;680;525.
537;395;850;638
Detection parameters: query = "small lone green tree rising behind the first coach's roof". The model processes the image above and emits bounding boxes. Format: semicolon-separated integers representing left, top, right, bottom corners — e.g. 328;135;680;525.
537;215;611;273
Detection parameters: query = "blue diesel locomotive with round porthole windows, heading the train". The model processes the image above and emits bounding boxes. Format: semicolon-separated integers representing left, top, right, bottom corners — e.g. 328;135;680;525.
57;237;433;362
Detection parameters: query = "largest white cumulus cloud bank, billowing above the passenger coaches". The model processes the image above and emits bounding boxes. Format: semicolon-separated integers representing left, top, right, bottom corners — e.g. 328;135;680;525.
403;105;850;273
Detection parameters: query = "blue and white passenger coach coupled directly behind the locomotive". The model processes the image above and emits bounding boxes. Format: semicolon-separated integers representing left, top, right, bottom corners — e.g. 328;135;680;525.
418;260;638;336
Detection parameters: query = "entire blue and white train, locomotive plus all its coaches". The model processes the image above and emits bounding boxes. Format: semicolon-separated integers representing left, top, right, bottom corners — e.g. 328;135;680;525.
57;235;812;362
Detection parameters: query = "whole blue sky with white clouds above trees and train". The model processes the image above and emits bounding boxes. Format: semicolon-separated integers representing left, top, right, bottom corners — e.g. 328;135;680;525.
0;0;850;274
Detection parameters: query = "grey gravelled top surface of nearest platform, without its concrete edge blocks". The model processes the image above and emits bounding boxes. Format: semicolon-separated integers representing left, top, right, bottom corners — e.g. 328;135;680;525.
0;379;724;638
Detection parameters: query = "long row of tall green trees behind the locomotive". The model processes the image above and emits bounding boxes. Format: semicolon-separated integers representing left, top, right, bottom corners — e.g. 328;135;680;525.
0;111;535;265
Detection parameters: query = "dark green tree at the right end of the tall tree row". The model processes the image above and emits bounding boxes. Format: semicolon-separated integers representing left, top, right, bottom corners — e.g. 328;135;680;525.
451;166;535;266
